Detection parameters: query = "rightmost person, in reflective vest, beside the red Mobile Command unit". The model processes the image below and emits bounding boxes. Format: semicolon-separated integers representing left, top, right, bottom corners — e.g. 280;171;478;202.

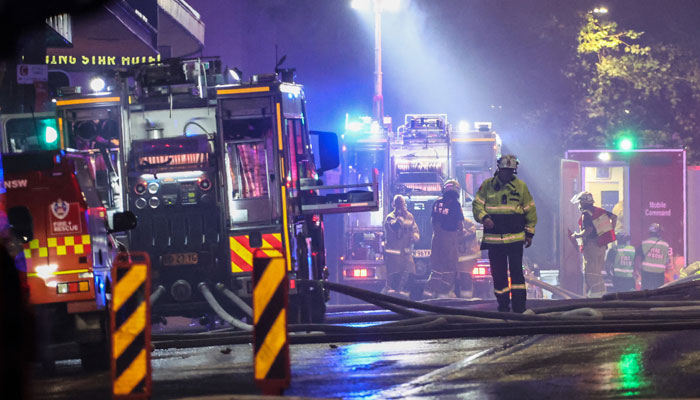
636;222;670;289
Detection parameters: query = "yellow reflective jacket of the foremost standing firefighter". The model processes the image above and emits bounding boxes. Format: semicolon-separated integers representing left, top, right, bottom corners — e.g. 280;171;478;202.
472;176;537;249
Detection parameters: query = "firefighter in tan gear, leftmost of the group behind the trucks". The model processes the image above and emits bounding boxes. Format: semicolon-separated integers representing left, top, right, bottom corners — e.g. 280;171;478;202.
384;194;420;296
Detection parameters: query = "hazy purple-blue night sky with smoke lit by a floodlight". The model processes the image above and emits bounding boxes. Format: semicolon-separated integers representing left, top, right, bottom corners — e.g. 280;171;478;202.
188;0;700;261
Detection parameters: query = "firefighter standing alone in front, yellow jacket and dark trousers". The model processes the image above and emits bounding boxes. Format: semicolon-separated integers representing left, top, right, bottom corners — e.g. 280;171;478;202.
472;154;537;313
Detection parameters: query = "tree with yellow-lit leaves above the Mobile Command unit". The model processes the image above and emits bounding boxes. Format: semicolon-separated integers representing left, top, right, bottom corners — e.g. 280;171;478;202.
562;13;700;163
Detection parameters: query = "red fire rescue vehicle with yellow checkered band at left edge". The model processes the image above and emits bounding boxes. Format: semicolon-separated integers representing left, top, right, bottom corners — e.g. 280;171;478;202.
2;150;136;370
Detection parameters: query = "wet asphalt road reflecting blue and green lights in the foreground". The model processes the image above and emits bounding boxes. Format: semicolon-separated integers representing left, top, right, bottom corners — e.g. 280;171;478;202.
32;330;700;399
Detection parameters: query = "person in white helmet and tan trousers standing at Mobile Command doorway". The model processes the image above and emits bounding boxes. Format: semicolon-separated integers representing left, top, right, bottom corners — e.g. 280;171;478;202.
571;192;617;297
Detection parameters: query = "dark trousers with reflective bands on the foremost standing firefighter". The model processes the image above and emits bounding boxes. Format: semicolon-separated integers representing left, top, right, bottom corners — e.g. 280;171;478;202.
489;242;527;313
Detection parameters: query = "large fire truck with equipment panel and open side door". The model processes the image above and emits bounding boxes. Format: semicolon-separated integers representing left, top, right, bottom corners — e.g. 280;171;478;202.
50;59;378;321
